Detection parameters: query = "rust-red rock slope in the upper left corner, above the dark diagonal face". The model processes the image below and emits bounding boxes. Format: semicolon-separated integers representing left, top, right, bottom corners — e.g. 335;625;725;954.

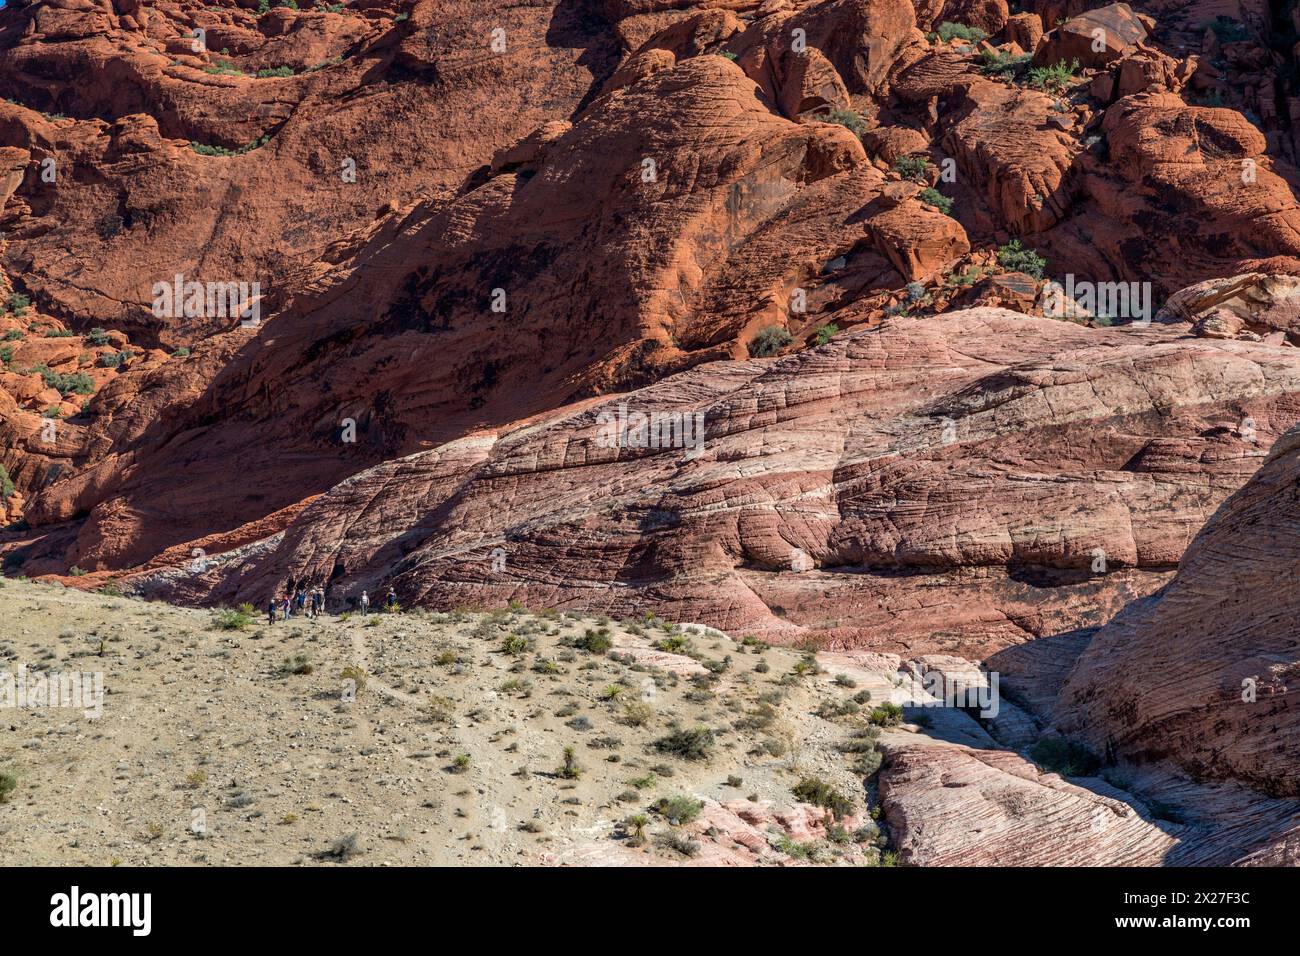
0;0;616;346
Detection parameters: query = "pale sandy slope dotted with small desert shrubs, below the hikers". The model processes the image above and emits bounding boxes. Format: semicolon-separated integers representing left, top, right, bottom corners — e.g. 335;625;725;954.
0;580;892;865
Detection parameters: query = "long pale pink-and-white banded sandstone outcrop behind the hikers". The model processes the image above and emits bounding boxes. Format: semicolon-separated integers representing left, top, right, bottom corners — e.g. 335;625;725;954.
129;310;1300;657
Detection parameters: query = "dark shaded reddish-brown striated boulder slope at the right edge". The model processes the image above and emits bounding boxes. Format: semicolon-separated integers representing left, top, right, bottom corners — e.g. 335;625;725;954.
1056;429;1300;797
